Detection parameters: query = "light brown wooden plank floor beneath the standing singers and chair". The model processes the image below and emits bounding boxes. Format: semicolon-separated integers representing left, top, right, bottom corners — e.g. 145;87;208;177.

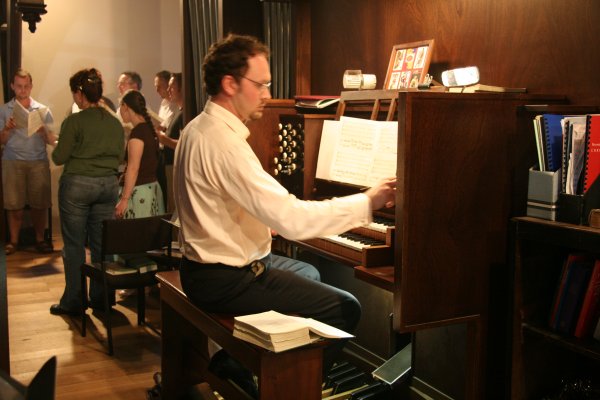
6;221;160;400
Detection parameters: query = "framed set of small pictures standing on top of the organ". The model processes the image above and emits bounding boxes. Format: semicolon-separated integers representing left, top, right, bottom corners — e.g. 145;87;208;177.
383;39;433;89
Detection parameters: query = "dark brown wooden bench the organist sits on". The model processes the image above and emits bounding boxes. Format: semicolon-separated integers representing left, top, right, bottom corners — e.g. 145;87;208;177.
156;271;323;400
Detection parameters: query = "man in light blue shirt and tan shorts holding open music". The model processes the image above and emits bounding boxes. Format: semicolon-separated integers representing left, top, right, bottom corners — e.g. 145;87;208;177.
0;69;56;255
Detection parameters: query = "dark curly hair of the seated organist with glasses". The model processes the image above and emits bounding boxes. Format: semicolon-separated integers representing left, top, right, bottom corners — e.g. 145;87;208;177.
202;34;269;96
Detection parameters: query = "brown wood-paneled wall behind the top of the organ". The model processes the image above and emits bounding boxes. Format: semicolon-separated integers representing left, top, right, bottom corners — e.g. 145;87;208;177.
310;0;600;104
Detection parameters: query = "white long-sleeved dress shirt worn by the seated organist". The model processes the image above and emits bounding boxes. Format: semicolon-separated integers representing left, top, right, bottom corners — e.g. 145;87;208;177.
173;100;372;267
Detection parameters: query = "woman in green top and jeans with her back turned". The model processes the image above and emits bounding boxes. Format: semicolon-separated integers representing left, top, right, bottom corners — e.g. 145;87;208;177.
50;68;125;315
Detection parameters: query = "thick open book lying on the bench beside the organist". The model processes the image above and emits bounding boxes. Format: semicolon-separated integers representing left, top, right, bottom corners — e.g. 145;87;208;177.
233;311;354;353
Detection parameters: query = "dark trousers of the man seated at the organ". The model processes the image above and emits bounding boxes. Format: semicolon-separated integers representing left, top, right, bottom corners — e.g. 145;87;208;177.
180;254;361;375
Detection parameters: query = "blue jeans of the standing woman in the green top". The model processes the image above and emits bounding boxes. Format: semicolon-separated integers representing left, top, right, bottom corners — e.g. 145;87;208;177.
58;174;119;311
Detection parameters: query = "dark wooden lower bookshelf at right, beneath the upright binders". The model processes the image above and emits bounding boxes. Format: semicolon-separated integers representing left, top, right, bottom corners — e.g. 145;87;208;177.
511;217;600;399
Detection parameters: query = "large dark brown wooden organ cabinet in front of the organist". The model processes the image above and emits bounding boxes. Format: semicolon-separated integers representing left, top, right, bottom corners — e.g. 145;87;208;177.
250;90;565;399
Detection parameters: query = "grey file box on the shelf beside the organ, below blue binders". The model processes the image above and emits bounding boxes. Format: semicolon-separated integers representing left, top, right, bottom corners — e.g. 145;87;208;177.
527;167;562;221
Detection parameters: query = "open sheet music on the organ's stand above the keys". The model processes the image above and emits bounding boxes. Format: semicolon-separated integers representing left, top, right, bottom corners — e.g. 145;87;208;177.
316;117;398;187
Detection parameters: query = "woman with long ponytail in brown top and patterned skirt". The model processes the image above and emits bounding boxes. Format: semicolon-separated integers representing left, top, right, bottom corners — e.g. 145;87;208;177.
115;90;165;219
